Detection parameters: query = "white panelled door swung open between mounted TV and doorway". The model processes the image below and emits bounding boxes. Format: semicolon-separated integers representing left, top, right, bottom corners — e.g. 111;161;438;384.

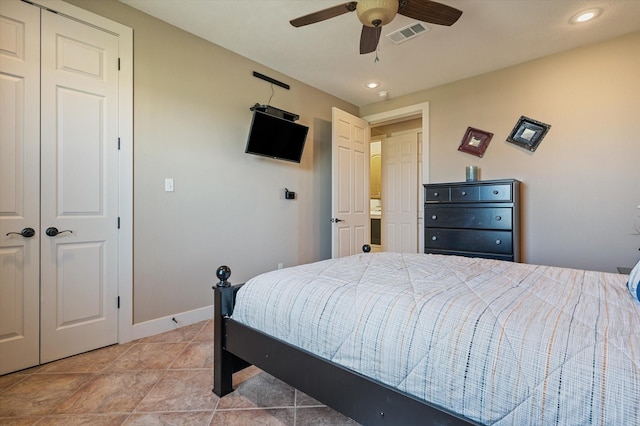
331;108;371;258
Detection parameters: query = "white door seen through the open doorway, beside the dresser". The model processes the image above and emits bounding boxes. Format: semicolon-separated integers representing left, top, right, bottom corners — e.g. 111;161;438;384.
381;133;418;253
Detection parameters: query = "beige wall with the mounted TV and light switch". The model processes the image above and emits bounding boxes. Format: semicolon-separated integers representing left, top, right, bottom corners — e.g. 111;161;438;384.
69;0;358;323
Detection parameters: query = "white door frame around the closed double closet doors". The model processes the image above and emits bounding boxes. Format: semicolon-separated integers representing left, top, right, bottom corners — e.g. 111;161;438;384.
31;0;133;343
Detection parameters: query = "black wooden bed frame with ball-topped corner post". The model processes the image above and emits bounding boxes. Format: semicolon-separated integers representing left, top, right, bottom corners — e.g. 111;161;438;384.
213;267;477;426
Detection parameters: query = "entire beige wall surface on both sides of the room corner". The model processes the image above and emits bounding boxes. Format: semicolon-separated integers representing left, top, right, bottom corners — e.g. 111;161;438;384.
69;0;640;323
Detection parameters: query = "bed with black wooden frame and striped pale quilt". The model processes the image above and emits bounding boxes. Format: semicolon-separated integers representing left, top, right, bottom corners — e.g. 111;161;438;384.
213;253;640;425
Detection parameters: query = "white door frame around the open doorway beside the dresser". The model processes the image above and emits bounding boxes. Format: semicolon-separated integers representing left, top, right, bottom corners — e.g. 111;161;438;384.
362;102;430;252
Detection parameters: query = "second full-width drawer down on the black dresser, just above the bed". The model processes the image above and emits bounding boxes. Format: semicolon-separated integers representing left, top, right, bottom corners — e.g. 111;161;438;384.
424;228;513;255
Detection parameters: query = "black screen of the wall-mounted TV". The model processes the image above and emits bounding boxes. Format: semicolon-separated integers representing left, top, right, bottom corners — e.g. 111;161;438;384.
245;110;309;163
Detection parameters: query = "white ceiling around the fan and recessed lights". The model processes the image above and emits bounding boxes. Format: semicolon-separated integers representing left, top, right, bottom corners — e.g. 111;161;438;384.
120;0;640;106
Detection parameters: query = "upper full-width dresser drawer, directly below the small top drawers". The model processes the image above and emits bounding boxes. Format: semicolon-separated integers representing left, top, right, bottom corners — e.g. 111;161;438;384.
424;205;513;230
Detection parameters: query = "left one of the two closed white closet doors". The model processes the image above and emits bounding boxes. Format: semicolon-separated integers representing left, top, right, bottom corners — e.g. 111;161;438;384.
0;0;40;374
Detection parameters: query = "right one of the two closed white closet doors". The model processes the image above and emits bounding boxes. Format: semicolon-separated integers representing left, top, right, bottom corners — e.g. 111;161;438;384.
40;7;118;362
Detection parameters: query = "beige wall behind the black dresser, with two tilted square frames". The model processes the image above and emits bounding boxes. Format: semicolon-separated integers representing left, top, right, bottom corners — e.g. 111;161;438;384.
360;33;640;271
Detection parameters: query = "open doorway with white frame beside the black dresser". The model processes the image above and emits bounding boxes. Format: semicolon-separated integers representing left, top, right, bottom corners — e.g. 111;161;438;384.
363;103;429;252
